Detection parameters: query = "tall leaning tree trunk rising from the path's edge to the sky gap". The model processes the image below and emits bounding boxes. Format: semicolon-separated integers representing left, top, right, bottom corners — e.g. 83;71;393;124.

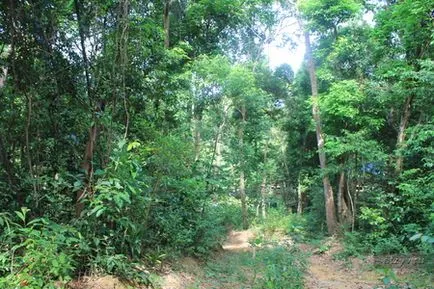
304;31;337;235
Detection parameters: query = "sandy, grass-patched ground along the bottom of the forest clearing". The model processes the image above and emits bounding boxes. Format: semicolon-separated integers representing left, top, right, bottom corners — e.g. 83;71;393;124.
71;230;434;289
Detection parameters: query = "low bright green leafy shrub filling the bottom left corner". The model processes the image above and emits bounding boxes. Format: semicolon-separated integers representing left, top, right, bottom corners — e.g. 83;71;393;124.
0;208;83;288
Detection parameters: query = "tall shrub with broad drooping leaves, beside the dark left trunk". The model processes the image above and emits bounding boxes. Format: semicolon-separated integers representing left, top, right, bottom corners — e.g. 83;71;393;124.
76;141;149;259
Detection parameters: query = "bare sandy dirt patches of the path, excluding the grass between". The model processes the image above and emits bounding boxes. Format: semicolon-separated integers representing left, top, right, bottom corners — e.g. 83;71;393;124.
161;230;386;289
